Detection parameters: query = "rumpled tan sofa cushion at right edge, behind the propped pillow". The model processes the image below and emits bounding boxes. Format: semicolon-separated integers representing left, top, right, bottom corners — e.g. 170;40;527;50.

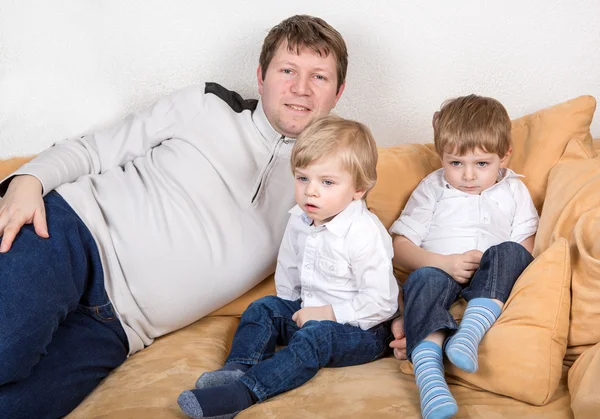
534;155;600;365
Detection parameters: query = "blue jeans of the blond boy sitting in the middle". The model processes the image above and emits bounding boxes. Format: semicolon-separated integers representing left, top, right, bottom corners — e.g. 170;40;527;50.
226;296;393;401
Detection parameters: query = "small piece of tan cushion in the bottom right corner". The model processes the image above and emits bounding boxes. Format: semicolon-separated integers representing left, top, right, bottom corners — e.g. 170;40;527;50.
569;343;600;419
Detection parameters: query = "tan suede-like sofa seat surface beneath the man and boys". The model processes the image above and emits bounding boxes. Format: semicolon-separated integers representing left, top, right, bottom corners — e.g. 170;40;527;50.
67;315;573;419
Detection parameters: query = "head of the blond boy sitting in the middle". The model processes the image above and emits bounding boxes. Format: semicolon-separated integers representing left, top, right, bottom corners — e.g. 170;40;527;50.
290;116;377;225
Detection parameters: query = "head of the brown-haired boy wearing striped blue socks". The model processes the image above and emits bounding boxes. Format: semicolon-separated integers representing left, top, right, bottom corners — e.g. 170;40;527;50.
433;95;512;194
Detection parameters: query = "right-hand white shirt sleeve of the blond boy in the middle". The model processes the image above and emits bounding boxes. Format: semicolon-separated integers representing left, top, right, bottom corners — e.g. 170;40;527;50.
332;218;398;330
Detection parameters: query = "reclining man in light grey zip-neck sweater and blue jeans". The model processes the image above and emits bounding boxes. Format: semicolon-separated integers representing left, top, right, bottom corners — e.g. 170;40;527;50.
0;16;347;418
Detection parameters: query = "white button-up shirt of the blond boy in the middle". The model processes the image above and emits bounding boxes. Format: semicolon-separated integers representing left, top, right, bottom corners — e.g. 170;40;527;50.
275;199;398;330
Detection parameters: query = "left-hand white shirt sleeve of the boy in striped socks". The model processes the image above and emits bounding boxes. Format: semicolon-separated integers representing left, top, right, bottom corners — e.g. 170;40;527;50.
390;179;436;246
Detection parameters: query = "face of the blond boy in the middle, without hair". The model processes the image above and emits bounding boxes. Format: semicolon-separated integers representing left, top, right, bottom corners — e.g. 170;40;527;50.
294;157;365;226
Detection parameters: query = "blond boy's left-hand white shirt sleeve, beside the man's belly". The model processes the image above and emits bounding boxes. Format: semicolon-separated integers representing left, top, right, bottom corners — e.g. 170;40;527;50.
275;215;301;301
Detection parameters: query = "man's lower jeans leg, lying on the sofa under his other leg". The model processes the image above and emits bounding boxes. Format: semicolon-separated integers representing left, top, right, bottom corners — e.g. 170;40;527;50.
0;305;128;419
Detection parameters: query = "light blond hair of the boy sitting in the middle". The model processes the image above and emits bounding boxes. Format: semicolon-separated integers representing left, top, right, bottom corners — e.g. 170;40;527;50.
290;115;378;195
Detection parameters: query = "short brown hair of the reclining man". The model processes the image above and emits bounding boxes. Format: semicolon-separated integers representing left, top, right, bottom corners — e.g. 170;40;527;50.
259;15;348;93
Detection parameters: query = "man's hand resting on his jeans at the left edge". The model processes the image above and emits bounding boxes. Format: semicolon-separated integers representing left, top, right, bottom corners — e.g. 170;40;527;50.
0;175;50;253
